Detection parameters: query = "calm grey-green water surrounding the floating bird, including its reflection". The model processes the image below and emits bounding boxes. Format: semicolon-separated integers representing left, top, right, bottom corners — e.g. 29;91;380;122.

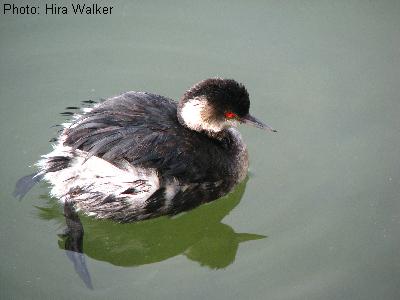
0;0;400;300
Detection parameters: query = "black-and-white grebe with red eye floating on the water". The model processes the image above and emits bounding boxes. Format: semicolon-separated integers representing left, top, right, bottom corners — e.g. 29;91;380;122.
24;78;275;222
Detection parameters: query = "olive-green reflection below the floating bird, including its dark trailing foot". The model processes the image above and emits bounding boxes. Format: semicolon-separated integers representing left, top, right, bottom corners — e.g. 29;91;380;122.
34;180;265;287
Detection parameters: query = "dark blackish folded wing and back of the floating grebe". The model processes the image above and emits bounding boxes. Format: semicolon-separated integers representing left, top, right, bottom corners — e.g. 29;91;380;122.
64;92;229;182
